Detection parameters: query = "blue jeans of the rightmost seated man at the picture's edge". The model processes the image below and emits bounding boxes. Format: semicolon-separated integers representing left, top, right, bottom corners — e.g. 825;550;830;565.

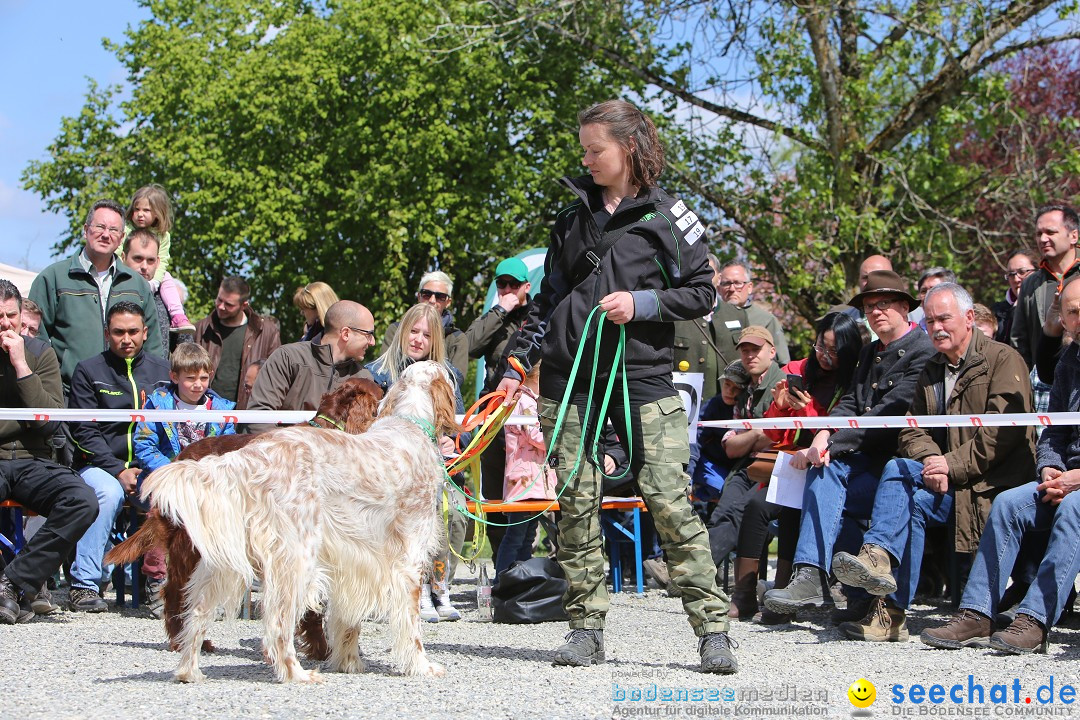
960;483;1080;628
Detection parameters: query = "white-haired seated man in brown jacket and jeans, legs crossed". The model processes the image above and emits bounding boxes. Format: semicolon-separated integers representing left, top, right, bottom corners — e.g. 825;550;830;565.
833;283;1035;642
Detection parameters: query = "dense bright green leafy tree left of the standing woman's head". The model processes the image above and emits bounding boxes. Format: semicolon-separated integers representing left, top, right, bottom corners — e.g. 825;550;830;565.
24;0;608;336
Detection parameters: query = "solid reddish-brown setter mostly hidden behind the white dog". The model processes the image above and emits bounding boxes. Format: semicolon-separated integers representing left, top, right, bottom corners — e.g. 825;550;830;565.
105;378;382;661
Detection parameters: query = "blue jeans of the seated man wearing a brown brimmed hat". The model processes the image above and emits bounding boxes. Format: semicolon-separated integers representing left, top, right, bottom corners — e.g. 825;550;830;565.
794;452;878;572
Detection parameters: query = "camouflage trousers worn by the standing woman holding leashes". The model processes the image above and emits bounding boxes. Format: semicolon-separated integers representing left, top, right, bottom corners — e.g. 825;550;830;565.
538;396;728;637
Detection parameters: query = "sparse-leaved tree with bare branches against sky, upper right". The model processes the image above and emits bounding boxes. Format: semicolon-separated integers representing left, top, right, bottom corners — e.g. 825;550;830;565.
459;0;1080;332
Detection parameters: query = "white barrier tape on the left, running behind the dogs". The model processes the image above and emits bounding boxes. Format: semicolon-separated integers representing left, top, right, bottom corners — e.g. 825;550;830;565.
0;408;538;425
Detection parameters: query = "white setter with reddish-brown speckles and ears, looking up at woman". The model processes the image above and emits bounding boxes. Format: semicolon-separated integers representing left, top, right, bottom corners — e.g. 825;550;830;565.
143;363;459;682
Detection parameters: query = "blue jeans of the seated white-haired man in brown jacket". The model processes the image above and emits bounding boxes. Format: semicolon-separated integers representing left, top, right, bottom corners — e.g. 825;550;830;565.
863;458;953;610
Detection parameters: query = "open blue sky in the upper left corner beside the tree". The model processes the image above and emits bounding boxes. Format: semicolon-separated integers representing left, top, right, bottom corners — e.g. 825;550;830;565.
0;0;149;270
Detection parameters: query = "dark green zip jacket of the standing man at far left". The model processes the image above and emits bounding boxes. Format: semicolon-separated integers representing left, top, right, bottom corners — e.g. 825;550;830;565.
29;250;165;390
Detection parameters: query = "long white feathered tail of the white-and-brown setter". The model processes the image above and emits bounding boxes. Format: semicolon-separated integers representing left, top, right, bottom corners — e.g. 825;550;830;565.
143;456;255;584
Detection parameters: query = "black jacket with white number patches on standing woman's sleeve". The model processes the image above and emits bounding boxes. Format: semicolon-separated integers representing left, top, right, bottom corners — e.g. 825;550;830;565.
507;176;716;386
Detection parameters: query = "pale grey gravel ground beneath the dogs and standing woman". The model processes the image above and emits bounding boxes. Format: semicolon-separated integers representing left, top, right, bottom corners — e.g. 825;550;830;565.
6;569;1080;720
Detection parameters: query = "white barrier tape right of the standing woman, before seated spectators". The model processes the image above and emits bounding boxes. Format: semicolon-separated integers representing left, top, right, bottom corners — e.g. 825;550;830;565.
698;412;1067;430
